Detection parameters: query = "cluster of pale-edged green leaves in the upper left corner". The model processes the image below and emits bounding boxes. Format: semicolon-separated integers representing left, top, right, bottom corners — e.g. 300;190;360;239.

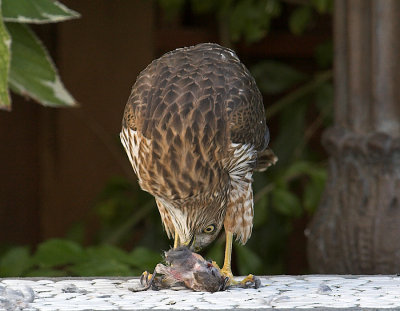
0;0;79;110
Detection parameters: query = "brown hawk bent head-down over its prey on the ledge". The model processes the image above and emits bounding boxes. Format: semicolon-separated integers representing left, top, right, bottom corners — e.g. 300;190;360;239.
121;43;275;280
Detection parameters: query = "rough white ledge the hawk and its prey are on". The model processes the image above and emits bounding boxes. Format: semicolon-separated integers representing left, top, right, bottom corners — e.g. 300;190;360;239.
0;275;400;311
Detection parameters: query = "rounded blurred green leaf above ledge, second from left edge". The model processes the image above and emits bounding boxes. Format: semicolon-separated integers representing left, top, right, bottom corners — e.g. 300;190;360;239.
34;239;85;268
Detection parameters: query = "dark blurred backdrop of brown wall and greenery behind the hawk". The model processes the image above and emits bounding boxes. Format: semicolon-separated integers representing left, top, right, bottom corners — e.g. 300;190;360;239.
0;0;333;276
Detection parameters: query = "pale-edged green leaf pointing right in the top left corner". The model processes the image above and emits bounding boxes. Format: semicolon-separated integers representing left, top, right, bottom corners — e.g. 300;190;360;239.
2;0;80;24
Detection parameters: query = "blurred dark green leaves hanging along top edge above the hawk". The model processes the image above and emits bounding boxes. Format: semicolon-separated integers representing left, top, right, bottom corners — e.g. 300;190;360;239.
158;0;333;43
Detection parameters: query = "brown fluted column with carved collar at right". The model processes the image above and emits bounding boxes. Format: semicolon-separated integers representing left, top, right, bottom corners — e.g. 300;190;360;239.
307;0;400;274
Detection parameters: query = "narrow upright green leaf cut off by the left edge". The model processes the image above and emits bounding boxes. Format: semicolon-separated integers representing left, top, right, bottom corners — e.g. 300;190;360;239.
0;4;11;110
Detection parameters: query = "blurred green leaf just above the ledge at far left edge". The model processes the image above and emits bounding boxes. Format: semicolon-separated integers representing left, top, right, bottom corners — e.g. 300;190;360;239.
0;247;32;277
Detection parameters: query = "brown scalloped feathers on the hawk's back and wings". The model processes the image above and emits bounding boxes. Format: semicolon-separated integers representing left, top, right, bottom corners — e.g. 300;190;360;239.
123;44;267;198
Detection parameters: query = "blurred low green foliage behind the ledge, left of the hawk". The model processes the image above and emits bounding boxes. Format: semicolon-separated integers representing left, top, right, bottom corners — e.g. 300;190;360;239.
0;239;162;277
